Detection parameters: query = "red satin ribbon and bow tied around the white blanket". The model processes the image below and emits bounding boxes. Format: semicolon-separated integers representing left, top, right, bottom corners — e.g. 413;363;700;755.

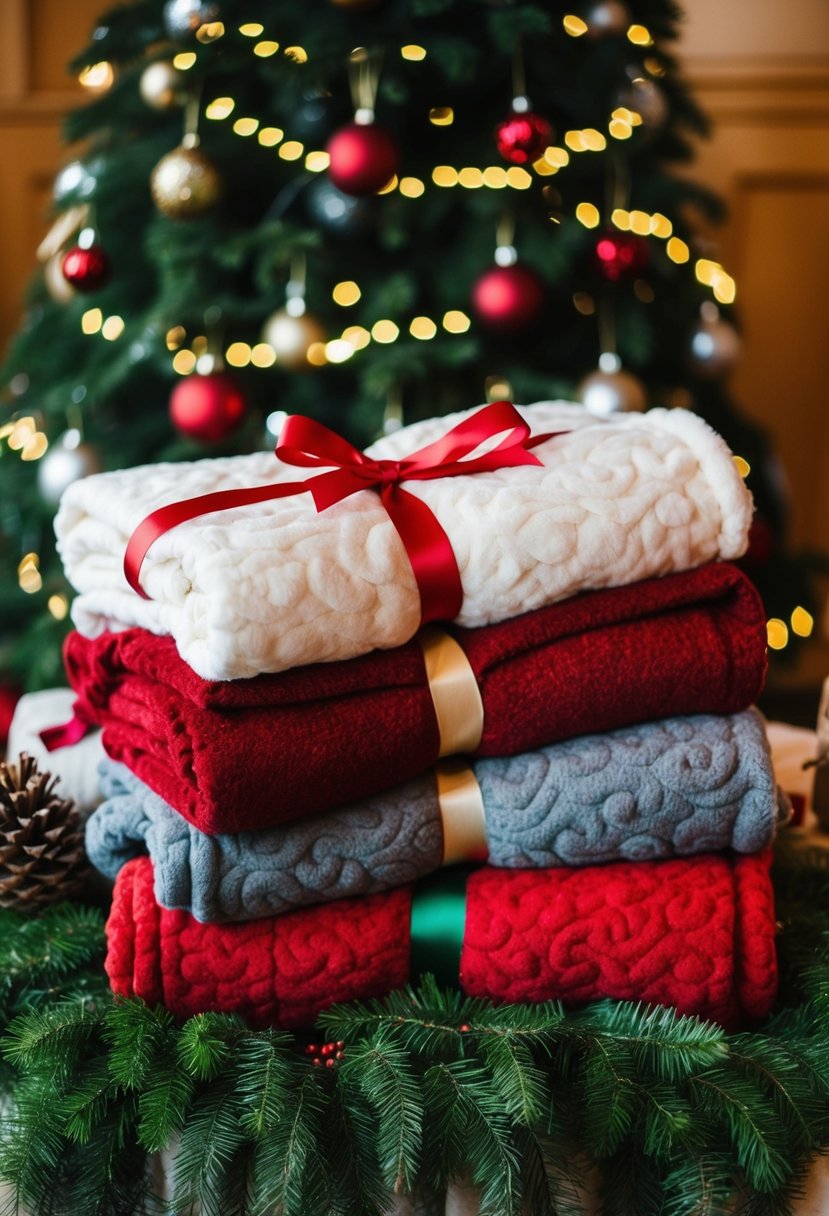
124;401;558;624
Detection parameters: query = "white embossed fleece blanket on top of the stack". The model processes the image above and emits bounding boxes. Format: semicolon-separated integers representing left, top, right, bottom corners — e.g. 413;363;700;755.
55;401;752;680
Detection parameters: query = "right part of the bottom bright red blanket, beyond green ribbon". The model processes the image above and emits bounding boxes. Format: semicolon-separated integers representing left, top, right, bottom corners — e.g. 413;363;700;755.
461;854;777;1029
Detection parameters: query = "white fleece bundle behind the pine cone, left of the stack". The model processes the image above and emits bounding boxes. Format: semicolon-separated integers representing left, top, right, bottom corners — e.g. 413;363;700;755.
6;688;105;815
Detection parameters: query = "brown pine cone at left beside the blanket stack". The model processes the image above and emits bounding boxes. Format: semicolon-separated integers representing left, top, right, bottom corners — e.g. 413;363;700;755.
0;751;89;907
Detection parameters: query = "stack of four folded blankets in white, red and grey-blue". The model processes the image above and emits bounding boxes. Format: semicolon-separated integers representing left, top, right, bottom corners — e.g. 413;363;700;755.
50;402;785;1026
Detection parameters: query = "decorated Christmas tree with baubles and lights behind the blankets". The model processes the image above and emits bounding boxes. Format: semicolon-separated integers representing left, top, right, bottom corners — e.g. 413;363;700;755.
0;0;808;687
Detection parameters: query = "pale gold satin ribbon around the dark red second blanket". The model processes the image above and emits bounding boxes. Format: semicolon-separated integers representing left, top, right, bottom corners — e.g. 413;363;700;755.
417;629;484;756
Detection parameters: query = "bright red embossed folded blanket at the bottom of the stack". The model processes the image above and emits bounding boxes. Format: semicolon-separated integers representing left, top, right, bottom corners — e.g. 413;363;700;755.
106;854;777;1028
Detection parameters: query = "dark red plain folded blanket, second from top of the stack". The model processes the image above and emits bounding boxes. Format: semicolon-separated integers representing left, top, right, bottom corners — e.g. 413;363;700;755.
64;563;766;833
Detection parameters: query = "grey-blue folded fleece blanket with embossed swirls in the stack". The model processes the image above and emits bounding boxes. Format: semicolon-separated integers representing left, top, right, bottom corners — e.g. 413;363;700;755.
86;710;783;921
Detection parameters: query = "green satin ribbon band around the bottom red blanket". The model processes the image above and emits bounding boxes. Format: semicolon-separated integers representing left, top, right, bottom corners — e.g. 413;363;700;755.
411;866;470;987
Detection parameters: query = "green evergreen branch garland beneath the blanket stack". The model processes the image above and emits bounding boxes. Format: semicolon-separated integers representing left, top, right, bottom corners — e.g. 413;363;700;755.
0;849;829;1216
